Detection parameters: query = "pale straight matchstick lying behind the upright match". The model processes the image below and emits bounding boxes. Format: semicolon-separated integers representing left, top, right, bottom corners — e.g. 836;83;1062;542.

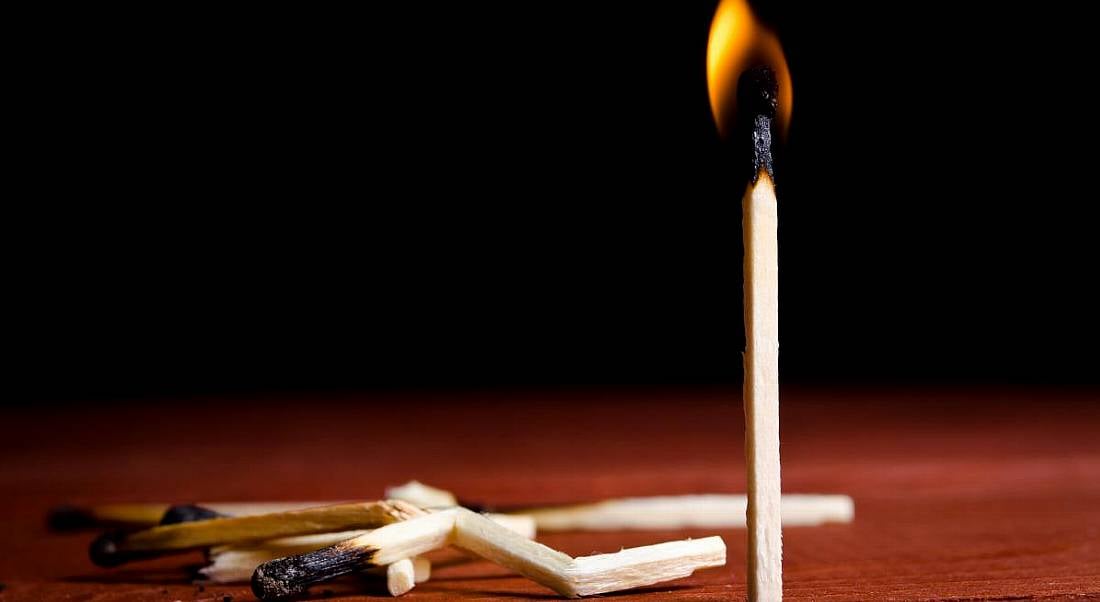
524;493;855;532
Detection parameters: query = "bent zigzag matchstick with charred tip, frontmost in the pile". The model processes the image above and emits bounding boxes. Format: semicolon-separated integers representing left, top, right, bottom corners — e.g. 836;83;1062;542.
252;507;726;600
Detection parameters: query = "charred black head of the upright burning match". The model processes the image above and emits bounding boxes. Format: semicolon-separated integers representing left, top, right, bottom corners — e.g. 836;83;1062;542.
734;66;779;183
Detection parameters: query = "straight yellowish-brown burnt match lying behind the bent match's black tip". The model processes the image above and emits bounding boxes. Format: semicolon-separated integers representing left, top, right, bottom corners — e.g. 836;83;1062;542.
89;500;425;567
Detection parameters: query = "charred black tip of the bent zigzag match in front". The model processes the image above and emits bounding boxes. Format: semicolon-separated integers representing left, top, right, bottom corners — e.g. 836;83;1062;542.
252;544;375;600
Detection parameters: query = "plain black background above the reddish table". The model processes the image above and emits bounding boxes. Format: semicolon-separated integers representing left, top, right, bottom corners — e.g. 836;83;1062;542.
6;1;1100;402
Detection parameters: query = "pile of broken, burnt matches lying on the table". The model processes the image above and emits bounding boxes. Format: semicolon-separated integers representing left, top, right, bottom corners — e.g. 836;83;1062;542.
51;481;853;600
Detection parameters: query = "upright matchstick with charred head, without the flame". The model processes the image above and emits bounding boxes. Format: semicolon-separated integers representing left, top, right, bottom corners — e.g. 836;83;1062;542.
737;67;783;602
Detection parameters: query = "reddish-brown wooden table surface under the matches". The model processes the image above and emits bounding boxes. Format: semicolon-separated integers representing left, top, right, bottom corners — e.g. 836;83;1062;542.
0;388;1100;602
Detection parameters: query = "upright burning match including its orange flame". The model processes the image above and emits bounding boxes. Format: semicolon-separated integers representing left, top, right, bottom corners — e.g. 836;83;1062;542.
707;0;791;602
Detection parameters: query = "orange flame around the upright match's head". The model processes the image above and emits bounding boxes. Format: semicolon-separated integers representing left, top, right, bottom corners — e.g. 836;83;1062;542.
706;0;794;134
